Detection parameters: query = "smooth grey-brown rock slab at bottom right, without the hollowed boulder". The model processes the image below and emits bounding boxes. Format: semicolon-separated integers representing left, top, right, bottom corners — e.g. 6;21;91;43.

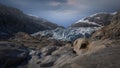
71;41;120;68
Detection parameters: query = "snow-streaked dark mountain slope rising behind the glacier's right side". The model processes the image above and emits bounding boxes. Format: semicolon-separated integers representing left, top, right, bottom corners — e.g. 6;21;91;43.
70;13;115;27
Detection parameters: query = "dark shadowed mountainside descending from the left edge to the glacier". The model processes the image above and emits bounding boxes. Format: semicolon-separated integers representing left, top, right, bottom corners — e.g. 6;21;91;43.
0;5;58;38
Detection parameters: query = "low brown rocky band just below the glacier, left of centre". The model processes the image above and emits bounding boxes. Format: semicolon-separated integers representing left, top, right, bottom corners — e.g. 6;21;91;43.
9;32;64;50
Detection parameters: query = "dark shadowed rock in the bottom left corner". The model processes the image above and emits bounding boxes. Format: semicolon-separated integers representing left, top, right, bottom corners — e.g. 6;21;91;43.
0;41;29;68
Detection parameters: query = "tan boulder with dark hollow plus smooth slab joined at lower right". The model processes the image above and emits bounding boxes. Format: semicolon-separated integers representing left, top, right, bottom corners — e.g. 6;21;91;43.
56;39;120;68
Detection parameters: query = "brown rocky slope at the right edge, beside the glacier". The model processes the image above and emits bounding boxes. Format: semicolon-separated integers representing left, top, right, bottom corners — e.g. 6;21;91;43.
92;12;120;39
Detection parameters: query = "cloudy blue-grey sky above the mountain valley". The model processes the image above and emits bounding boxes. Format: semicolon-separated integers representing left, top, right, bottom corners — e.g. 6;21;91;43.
0;0;120;27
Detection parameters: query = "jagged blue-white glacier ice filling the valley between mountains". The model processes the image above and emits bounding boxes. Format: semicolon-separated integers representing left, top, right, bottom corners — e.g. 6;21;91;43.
32;27;99;41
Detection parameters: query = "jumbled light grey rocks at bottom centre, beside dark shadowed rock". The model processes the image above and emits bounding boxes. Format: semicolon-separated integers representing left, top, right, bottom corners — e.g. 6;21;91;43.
27;44;76;68
